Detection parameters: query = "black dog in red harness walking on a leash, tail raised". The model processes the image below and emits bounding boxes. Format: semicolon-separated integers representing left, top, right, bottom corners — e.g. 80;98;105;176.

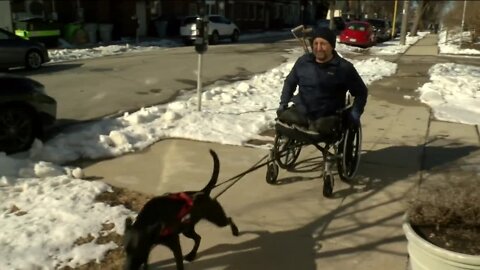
123;150;238;270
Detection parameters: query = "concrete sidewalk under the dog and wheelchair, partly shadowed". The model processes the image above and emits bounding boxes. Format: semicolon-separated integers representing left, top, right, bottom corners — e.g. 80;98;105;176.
84;35;480;270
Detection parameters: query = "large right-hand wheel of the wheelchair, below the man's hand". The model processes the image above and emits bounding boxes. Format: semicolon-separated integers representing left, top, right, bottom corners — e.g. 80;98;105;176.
337;127;362;181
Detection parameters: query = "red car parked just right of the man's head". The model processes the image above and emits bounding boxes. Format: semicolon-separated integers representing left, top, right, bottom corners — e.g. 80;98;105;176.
340;21;375;48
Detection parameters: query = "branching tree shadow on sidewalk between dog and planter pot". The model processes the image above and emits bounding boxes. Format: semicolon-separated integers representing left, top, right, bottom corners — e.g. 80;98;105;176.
150;182;407;270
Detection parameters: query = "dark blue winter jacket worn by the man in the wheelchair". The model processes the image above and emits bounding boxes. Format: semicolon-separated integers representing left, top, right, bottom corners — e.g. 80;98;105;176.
280;51;368;120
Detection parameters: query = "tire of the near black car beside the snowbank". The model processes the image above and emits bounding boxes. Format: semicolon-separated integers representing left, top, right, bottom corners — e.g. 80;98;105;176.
0;106;38;154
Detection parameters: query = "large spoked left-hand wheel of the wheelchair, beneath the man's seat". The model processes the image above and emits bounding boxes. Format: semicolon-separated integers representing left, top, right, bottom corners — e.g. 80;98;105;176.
273;134;302;169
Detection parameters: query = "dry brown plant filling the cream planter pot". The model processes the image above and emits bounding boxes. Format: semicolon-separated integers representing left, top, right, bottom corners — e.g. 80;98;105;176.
407;178;480;255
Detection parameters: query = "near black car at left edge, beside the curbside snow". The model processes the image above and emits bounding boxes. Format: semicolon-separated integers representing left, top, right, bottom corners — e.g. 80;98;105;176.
0;73;57;154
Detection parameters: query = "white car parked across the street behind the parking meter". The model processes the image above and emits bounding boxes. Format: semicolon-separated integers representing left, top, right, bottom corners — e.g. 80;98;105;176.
180;15;240;45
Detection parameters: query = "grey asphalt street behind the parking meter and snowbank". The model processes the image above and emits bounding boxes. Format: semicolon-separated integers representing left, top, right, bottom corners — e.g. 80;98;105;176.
14;37;298;125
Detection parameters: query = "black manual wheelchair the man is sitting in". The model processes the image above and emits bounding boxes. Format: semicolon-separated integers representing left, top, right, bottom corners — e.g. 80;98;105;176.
266;105;362;197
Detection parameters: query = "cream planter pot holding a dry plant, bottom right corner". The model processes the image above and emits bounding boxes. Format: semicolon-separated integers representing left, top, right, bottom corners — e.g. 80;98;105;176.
403;215;480;270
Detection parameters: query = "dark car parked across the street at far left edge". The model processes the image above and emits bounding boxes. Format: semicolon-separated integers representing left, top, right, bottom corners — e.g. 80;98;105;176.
0;28;50;69
